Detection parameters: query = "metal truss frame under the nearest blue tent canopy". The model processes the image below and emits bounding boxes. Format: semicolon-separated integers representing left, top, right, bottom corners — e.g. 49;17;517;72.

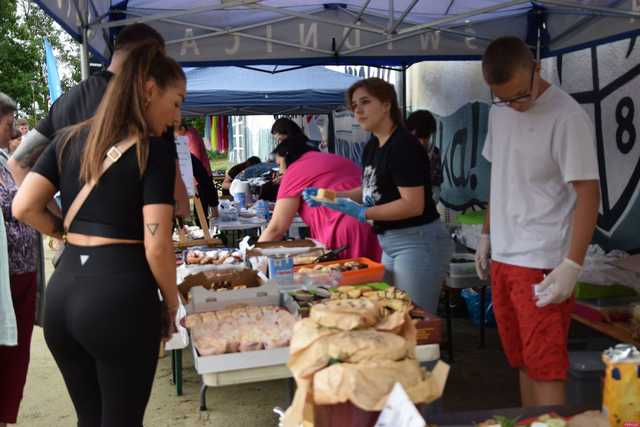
65;0;640;79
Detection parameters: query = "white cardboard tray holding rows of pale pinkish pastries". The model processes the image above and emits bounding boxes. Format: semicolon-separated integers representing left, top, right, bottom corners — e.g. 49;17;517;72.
188;290;298;375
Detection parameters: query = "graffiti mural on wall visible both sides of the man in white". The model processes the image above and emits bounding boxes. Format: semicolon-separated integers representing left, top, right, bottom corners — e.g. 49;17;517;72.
425;39;640;251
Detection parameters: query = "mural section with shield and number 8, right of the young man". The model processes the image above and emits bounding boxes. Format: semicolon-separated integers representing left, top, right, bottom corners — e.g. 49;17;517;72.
556;39;640;249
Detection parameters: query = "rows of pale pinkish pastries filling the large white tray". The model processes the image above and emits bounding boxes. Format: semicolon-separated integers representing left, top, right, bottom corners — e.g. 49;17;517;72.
186;306;296;356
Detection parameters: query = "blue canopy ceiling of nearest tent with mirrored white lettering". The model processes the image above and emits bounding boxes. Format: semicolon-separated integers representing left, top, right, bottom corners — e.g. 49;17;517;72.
36;0;640;66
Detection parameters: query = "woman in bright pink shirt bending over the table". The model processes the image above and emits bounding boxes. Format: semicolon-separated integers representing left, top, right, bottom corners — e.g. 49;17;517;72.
260;135;381;261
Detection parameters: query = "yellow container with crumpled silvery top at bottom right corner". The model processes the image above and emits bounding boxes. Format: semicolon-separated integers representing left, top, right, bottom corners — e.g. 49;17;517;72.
602;344;640;427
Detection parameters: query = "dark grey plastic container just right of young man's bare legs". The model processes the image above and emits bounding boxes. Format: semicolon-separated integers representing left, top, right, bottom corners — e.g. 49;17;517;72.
567;351;605;408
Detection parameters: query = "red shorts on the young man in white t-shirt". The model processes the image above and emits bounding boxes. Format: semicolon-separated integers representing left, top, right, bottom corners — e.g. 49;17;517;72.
491;261;574;381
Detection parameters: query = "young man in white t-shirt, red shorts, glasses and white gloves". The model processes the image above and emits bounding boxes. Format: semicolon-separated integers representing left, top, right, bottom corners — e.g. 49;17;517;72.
476;37;600;406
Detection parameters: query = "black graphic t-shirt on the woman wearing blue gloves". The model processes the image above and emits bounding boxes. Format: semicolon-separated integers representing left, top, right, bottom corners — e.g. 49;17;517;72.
362;127;439;233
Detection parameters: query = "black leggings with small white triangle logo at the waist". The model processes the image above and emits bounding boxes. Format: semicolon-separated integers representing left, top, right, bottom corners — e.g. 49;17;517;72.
44;244;161;427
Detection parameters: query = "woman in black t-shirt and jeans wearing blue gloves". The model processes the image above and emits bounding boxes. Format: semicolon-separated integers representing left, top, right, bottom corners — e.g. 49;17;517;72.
305;78;452;313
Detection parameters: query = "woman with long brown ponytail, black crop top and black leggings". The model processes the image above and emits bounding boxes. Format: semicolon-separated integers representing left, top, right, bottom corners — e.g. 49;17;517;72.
13;45;186;427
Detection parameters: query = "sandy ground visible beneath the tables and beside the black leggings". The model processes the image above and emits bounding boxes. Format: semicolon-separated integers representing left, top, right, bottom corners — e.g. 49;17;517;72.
18;242;604;427
